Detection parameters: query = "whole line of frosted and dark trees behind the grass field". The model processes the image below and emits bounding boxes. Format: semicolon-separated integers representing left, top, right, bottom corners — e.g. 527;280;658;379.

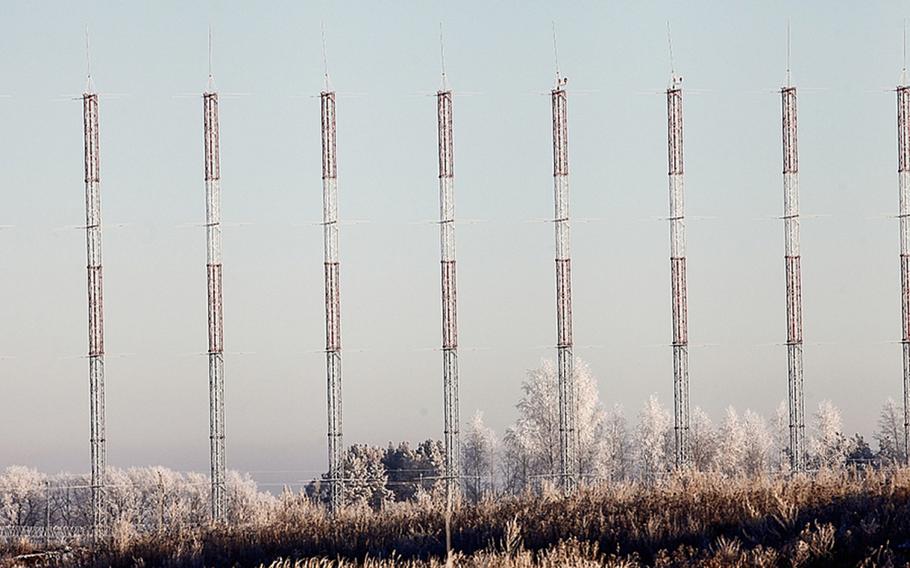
0;360;906;531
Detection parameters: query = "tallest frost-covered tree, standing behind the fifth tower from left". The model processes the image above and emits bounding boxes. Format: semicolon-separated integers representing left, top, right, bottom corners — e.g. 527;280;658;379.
503;359;606;489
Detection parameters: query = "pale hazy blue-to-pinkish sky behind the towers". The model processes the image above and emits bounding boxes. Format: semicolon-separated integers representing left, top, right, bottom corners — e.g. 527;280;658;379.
0;1;907;480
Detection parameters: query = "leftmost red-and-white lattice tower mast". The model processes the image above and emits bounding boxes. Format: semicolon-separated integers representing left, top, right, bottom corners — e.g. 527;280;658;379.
82;76;107;537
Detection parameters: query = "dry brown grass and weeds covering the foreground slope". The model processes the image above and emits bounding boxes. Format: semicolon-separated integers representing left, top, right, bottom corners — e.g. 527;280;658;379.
0;469;910;568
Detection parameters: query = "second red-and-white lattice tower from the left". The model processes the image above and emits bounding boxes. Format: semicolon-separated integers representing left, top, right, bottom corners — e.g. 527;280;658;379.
202;75;225;523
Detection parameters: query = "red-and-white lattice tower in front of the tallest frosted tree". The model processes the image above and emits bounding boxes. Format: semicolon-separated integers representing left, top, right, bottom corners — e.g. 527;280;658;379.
550;73;578;493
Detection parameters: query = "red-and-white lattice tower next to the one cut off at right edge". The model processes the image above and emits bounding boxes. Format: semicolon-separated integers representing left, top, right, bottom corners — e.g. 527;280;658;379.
780;82;806;472
